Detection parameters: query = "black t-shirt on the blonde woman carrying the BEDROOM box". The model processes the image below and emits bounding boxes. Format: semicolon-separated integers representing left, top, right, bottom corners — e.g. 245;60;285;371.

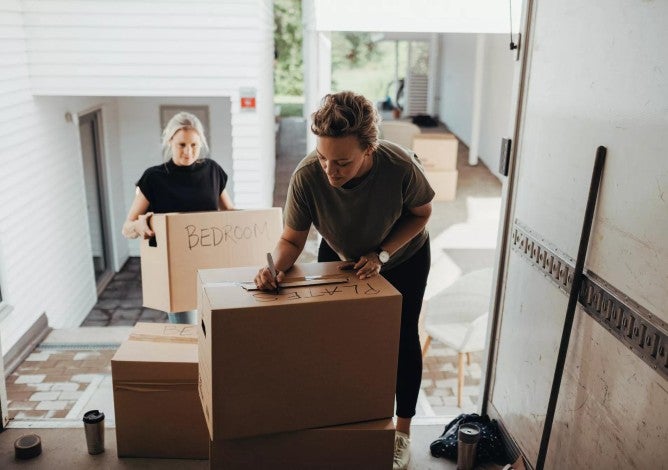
137;158;227;214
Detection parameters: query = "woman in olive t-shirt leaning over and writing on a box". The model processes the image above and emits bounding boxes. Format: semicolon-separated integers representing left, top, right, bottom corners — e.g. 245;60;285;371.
255;92;434;469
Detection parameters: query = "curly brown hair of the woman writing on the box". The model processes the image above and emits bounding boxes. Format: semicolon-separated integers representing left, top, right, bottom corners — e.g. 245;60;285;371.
311;91;380;151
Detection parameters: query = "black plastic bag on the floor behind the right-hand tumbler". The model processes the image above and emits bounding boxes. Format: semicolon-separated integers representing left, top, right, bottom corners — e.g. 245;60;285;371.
429;413;509;465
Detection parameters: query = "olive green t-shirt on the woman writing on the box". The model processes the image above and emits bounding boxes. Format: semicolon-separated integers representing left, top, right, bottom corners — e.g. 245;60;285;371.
285;140;434;271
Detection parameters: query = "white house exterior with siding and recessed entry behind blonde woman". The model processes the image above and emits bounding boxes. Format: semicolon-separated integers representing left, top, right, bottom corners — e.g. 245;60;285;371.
0;0;275;355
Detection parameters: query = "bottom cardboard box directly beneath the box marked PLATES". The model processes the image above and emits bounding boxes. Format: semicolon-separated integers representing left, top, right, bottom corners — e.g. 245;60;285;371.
209;419;394;470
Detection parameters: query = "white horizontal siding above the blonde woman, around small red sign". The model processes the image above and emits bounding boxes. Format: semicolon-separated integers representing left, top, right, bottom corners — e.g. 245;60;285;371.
22;0;275;208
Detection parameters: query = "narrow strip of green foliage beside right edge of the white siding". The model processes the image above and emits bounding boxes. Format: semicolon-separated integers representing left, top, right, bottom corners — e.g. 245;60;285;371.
274;0;304;96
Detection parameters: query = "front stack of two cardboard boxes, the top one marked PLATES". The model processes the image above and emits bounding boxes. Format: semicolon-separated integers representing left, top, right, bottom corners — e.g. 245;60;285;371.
198;263;401;469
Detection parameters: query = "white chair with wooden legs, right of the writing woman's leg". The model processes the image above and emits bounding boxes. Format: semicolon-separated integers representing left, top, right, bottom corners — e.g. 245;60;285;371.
422;268;492;407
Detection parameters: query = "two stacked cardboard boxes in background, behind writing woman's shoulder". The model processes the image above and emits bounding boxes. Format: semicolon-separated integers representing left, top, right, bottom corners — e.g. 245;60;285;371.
413;132;459;201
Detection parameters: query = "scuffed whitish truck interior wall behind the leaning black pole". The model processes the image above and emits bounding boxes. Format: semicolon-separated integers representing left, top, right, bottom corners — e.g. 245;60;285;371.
491;0;668;469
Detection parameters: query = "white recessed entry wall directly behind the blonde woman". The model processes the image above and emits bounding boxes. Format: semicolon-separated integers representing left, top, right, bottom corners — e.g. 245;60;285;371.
117;97;236;256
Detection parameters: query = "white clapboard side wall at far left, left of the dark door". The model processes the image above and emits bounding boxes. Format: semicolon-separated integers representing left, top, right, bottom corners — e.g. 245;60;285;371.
0;2;113;354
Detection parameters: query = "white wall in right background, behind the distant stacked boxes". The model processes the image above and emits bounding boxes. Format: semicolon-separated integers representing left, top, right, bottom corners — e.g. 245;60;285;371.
438;34;515;176
